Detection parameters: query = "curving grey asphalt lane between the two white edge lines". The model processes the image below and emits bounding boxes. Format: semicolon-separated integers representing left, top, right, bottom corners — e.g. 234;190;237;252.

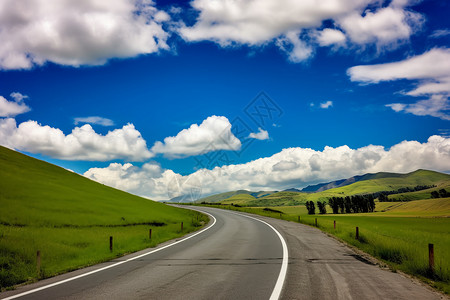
0;208;287;299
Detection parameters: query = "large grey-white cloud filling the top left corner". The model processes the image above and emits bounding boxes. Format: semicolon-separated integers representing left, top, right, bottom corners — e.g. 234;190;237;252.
0;0;169;69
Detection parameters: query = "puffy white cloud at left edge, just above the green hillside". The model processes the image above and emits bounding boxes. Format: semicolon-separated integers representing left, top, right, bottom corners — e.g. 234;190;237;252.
0;118;152;161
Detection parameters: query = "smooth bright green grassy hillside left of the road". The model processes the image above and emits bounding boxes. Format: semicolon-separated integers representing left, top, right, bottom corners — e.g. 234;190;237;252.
0;147;207;288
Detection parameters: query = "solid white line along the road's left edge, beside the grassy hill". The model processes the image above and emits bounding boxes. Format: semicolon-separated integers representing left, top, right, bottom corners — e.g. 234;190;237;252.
2;211;216;300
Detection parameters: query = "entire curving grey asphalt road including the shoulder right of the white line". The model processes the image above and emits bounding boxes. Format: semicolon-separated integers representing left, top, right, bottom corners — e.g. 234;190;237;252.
0;208;441;300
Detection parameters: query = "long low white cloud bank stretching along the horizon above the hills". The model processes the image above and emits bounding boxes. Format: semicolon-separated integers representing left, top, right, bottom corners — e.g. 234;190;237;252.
84;136;450;200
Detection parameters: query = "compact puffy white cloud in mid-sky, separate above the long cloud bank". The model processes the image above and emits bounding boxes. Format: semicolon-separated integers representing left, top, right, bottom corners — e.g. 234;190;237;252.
151;116;241;158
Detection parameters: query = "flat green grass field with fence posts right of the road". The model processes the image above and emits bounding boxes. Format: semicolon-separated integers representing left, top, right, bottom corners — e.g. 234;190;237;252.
199;198;450;294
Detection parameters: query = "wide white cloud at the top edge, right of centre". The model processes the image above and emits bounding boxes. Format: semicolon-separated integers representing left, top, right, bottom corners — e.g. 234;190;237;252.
178;0;423;62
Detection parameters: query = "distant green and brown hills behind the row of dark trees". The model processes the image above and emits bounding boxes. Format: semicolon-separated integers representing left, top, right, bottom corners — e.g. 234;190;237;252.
217;170;450;206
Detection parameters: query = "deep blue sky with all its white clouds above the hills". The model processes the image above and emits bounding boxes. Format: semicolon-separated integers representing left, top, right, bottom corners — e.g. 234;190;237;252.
0;0;450;200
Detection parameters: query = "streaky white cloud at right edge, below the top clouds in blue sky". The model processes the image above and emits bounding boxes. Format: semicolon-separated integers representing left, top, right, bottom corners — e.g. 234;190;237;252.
347;48;450;120
